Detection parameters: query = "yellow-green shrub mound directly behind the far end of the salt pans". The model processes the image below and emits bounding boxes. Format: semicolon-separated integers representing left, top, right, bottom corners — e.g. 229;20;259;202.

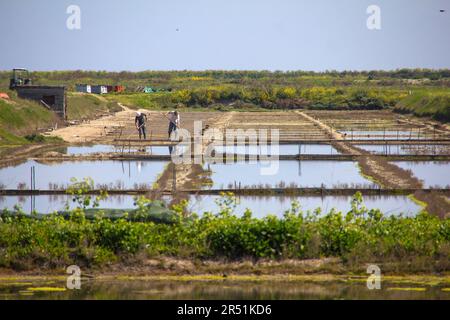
109;85;406;111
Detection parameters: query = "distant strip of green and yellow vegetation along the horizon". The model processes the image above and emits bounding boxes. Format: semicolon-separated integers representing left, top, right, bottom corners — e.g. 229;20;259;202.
0;69;450;91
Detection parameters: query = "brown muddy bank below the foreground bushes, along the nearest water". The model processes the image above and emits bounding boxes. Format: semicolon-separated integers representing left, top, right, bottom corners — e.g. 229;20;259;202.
0;257;450;283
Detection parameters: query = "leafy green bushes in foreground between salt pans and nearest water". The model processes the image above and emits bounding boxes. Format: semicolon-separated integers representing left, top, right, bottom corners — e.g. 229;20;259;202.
0;189;450;271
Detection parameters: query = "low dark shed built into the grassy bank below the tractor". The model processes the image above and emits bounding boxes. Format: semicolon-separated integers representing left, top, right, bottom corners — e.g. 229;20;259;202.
14;85;67;119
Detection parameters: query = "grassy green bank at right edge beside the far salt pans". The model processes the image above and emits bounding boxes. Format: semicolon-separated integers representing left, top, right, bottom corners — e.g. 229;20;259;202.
394;90;450;122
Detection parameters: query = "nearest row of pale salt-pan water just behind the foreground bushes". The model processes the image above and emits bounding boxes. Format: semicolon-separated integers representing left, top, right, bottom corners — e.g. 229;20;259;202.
0;195;421;218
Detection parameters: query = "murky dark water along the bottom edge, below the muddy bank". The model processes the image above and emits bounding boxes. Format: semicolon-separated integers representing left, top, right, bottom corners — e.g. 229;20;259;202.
0;280;450;300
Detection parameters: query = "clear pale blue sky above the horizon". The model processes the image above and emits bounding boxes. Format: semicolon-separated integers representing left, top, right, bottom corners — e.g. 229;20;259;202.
0;0;450;71
